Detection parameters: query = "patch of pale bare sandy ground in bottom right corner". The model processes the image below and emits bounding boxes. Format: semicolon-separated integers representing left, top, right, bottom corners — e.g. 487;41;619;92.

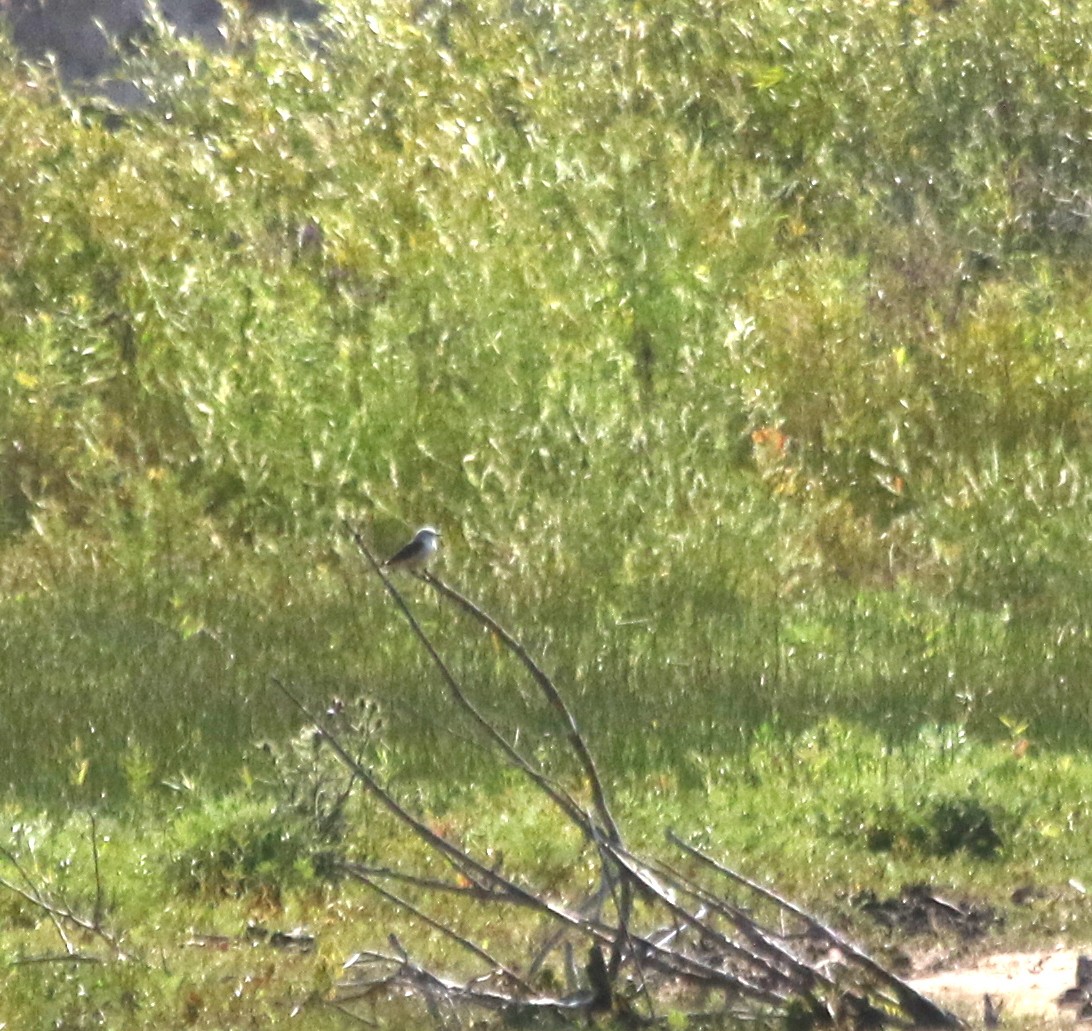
911;946;1092;1028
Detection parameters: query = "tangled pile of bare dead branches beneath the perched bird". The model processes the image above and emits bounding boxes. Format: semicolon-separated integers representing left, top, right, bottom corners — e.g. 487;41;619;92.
275;530;960;1028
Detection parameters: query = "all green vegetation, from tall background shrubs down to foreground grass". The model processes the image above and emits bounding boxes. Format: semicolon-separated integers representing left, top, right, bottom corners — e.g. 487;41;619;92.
0;0;1092;1027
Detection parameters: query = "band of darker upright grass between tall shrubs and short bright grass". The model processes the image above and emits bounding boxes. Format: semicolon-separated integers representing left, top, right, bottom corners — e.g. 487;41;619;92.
8;552;1090;804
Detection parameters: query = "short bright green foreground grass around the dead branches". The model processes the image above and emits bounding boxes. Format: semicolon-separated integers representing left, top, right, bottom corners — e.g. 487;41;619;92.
0;721;1092;1029
